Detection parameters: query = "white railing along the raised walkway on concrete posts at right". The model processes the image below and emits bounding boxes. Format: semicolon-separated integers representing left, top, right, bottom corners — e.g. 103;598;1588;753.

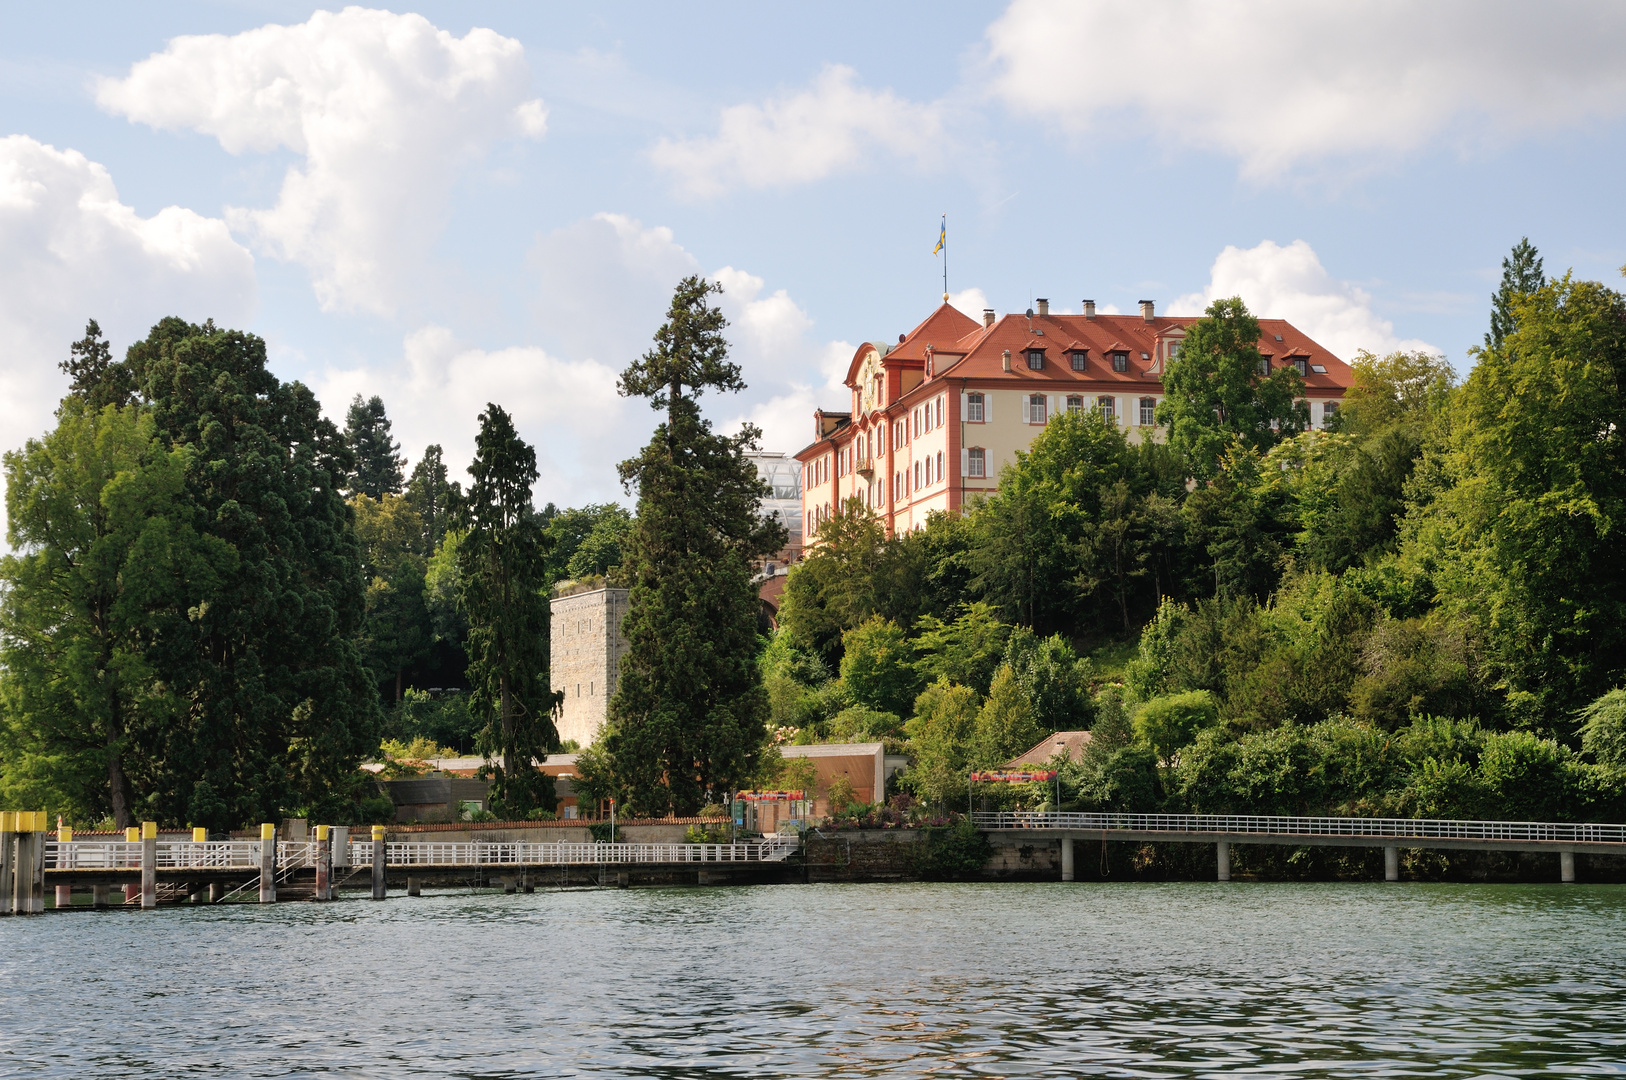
971;810;1626;844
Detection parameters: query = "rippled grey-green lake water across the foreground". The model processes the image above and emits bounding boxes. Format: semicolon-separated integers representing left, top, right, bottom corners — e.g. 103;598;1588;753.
0;883;1626;1080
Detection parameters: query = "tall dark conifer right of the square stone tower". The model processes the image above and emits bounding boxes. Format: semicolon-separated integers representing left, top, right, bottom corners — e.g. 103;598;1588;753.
605;277;785;815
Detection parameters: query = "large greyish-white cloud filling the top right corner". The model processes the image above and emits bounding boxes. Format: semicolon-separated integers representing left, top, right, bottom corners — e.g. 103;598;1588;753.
987;0;1626;177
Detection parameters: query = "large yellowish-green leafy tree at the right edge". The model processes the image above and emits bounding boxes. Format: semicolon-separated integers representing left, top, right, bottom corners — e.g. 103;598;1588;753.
1408;275;1626;735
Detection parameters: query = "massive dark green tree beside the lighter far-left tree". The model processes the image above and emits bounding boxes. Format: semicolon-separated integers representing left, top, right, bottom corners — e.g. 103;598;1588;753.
124;319;382;828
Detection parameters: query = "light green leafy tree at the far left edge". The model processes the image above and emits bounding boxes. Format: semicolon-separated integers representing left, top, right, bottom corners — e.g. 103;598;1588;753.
0;400;203;828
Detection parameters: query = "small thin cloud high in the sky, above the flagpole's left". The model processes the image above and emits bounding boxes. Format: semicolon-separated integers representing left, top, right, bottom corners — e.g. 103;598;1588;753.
650;63;943;197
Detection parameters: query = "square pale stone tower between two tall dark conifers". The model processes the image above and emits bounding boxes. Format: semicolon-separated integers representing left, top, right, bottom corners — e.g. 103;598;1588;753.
548;589;628;748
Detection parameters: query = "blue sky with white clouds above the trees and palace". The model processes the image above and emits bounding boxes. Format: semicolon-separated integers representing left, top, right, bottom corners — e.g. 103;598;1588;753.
0;0;1626;523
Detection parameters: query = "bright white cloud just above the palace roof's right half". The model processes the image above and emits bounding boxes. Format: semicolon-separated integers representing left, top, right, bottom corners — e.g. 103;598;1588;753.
1169;241;1441;359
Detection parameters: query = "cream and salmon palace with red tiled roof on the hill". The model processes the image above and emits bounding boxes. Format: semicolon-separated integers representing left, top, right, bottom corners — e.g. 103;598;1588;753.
797;299;1350;540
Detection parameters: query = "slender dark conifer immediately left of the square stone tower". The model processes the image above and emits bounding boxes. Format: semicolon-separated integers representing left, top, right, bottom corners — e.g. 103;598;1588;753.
457;403;559;817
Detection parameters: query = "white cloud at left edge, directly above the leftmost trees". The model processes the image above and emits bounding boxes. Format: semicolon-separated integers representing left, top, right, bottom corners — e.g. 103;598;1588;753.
0;135;255;536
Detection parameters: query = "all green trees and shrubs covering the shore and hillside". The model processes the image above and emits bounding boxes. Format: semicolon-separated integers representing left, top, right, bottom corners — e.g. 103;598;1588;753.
0;242;1626;884
